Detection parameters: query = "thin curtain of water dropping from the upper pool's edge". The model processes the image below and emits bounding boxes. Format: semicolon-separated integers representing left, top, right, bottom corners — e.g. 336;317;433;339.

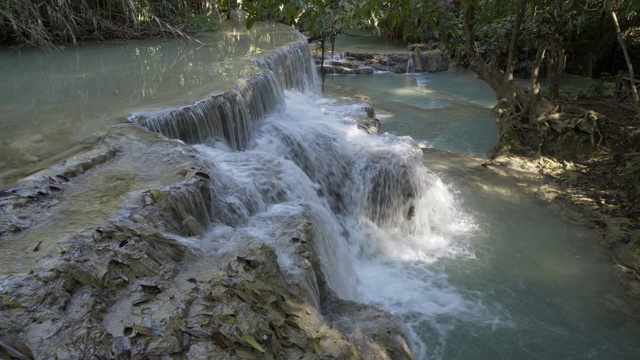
129;41;318;150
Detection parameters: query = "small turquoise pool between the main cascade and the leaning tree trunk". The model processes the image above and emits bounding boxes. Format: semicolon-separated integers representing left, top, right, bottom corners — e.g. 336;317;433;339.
327;73;497;155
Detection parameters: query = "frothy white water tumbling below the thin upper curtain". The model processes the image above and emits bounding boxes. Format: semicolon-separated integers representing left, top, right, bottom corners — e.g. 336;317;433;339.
192;92;501;359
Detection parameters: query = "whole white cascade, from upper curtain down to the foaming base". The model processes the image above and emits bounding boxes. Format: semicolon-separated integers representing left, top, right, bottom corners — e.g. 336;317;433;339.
132;32;498;359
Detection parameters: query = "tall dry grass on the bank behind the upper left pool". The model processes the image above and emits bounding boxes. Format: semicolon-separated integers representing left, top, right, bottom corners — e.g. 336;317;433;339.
0;0;219;49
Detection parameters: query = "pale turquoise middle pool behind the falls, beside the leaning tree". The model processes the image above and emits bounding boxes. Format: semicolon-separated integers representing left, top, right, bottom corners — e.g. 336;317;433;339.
325;71;498;156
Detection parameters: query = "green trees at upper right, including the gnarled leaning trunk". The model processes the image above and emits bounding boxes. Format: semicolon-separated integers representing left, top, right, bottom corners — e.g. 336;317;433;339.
241;0;640;155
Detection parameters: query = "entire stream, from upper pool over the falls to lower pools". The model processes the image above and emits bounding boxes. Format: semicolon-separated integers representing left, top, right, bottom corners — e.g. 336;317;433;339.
0;25;640;360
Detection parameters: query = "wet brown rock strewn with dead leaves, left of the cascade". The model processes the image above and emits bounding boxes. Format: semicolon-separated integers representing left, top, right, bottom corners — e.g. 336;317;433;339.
0;125;412;359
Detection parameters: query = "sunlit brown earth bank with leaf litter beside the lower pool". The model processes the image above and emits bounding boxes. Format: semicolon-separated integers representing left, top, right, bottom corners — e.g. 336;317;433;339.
484;99;640;320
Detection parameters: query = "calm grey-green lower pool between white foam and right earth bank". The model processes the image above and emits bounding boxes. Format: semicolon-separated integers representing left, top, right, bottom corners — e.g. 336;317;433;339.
421;149;640;360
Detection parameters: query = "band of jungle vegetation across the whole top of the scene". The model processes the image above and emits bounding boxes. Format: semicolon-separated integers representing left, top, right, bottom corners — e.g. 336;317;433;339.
0;0;640;189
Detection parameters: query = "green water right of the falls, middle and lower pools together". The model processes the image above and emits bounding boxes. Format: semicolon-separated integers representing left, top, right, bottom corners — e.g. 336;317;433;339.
326;70;640;359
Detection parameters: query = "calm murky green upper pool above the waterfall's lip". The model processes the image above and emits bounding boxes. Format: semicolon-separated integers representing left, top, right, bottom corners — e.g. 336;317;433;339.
0;24;302;188
